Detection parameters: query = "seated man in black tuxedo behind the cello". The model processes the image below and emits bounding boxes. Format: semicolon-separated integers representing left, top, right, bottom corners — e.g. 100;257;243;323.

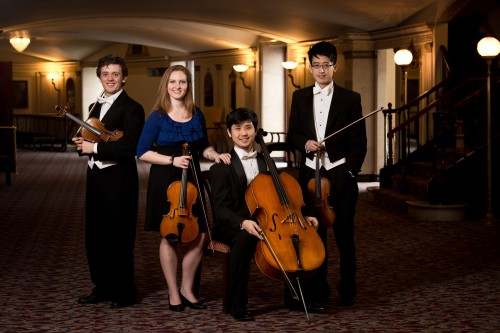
210;108;318;321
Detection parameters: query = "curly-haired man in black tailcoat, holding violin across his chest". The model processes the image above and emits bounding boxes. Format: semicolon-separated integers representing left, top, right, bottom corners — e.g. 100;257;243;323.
73;55;144;308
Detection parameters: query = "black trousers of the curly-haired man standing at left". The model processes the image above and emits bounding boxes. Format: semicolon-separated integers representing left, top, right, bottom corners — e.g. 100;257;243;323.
85;163;139;301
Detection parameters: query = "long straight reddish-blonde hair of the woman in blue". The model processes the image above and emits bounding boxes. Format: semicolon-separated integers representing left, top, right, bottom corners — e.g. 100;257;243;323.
153;65;195;114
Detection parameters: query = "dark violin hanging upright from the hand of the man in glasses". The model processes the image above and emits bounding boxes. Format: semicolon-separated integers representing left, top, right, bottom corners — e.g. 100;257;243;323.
307;150;335;227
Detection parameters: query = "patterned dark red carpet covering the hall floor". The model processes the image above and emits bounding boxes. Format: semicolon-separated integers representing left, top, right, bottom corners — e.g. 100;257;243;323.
0;151;500;332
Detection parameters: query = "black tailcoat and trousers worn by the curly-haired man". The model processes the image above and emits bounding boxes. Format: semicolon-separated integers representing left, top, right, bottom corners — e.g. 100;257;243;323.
85;91;145;301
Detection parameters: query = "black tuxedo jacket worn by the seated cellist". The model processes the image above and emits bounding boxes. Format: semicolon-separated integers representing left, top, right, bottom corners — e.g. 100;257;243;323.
210;149;267;236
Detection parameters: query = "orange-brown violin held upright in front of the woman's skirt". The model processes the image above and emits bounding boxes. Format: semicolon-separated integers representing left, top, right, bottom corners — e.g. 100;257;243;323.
160;143;200;243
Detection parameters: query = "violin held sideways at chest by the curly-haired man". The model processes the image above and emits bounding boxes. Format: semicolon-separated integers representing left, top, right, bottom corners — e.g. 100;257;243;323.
54;105;123;142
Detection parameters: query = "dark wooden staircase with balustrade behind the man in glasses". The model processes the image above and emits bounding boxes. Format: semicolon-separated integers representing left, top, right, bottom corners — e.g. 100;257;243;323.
374;79;499;220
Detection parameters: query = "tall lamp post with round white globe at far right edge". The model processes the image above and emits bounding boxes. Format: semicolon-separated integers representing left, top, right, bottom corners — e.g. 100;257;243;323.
477;37;500;219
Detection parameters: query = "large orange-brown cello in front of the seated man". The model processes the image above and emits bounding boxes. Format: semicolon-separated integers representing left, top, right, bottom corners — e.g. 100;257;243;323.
245;129;325;313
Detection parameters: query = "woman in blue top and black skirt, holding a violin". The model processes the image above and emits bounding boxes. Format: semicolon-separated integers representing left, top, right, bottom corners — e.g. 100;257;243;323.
137;65;230;311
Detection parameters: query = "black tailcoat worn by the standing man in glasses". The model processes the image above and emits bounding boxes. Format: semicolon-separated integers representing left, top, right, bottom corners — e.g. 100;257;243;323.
287;83;367;175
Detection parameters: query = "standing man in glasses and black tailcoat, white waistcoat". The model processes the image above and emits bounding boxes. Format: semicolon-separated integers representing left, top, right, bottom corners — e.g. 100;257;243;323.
287;42;367;306
